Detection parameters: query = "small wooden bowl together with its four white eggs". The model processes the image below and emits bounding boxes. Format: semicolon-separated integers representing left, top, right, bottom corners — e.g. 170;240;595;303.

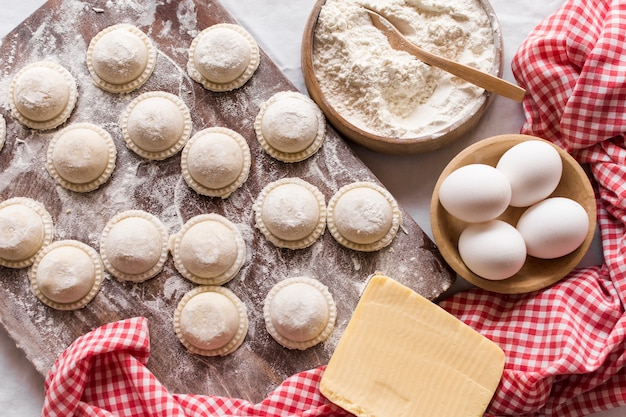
430;134;596;294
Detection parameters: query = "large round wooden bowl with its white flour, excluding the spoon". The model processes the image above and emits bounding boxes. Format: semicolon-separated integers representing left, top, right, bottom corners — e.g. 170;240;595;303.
301;0;503;155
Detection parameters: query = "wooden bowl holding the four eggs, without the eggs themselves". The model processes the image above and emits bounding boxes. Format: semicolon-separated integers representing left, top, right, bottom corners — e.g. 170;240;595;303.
430;134;597;294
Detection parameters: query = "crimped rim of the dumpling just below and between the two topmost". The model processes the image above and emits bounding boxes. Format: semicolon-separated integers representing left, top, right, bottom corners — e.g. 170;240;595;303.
120;91;192;161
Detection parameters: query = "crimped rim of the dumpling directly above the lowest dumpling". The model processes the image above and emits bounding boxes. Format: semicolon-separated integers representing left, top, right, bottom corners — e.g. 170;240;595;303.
168;213;247;285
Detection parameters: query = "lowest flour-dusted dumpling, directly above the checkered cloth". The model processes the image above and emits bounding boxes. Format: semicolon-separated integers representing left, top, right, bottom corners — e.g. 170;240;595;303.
174;286;248;356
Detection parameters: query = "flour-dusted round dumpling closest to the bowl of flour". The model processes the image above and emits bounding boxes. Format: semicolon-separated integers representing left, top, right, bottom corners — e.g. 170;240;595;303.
254;91;326;162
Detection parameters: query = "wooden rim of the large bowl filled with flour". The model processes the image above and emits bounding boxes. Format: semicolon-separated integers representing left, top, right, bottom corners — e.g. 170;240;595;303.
301;0;504;155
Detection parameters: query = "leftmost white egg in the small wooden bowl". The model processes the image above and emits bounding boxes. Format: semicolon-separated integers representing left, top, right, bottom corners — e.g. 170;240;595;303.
439;164;511;223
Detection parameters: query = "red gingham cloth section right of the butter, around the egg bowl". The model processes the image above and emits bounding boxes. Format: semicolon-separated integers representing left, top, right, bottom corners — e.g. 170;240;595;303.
441;0;626;417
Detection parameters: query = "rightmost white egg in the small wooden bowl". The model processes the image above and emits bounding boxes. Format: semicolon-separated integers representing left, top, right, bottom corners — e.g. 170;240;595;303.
517;197;589;259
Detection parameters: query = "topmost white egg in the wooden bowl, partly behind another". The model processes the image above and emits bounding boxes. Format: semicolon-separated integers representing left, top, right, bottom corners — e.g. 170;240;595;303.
496;140;563;207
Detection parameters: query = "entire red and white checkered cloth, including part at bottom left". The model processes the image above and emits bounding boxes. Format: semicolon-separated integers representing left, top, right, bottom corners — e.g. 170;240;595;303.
42;0;626;417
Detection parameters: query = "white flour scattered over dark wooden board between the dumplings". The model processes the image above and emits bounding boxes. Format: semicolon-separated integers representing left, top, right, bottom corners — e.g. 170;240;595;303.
0;0;450;402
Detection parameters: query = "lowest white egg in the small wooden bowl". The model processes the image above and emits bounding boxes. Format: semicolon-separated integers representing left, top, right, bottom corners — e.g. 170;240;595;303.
458;220;526;280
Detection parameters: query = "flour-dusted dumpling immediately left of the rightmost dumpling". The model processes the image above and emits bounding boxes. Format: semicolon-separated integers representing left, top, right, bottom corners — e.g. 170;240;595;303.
254;178;326;249
